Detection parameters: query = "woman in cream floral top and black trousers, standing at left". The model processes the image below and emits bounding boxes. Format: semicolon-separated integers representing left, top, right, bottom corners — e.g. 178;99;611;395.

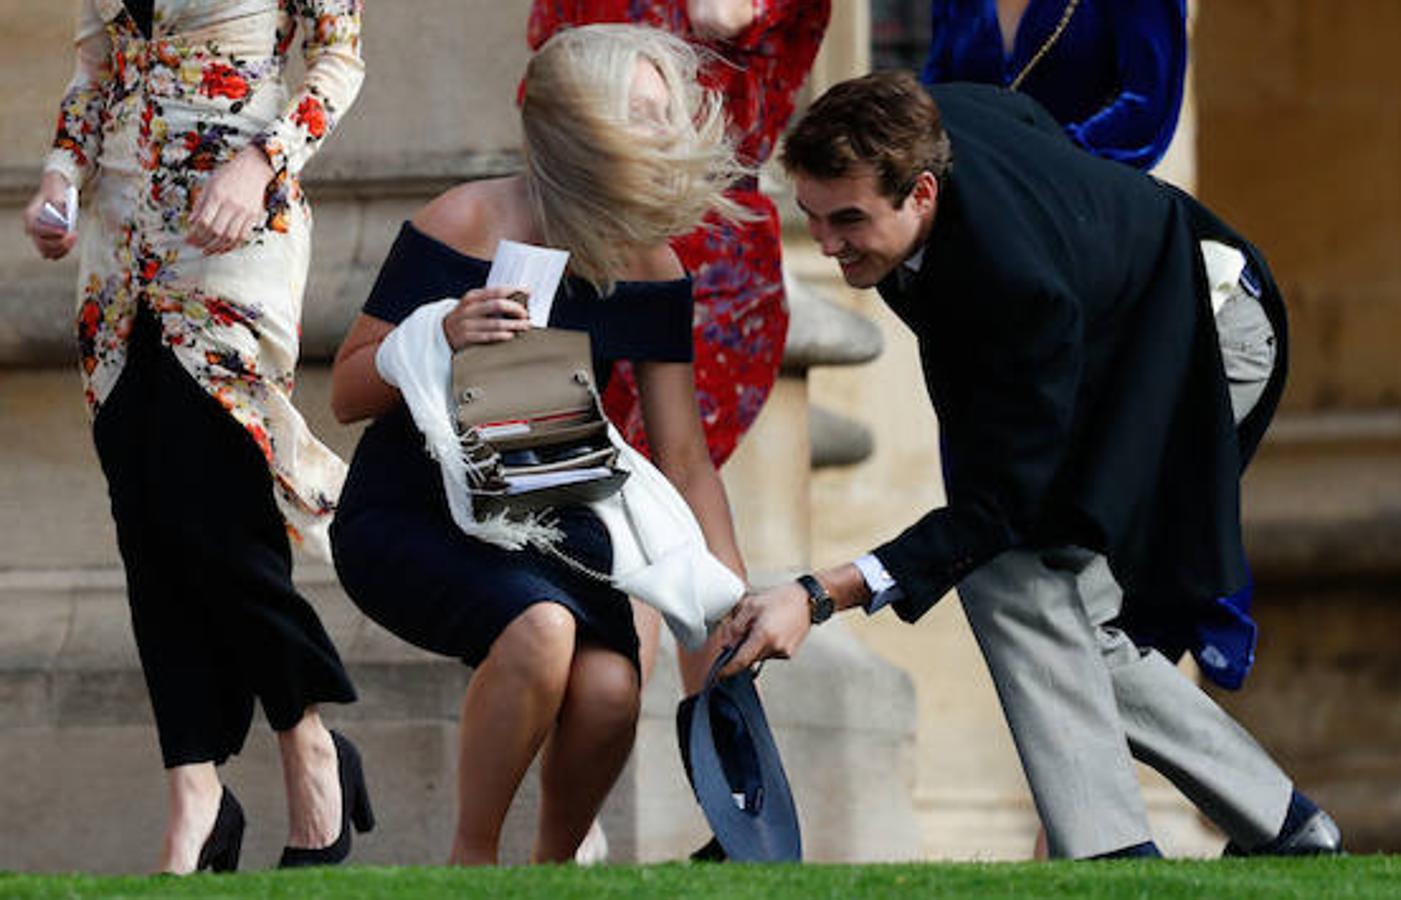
25;0;370;872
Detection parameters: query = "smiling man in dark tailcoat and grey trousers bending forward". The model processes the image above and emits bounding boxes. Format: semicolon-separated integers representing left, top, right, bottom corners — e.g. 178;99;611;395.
727;73;1341;858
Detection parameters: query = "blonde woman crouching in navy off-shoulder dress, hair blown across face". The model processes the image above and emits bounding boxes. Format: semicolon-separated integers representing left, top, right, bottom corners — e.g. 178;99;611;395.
332;25;743;865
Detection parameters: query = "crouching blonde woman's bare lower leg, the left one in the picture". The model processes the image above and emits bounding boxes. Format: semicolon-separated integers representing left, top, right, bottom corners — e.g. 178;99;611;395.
450;603;577;865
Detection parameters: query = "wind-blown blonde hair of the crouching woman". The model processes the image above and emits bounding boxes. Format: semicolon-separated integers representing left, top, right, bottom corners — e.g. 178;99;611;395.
521;25;752;293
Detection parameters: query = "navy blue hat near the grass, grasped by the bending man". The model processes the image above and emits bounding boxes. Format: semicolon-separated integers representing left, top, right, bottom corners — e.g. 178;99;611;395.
677;648;803;862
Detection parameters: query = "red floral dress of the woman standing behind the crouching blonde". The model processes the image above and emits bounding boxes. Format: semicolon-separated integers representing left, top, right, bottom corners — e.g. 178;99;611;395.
528;0;831;465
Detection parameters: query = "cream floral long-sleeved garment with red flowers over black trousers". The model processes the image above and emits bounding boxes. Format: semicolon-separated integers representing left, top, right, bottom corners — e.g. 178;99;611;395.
45;0;364;558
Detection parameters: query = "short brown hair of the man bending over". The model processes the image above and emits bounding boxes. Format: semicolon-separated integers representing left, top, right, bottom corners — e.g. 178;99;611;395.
779;70;953;206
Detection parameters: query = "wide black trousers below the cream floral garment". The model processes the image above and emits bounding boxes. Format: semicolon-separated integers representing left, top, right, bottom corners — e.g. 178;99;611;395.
92;307;354;767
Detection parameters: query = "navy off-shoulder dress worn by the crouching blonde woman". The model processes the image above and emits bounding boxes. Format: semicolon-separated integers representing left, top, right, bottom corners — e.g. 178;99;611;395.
331;223;692;666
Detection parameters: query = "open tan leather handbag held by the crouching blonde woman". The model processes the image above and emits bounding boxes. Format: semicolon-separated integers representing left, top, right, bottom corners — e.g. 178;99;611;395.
453;328;628;516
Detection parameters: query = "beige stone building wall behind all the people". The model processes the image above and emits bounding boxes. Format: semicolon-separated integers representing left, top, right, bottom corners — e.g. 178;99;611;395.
0;0;1401;869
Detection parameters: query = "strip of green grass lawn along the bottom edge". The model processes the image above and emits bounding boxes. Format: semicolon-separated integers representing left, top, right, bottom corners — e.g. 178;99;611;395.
0;857;1401;900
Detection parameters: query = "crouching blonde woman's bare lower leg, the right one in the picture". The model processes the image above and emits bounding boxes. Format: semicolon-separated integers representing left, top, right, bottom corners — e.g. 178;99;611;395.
532;633;642;862
